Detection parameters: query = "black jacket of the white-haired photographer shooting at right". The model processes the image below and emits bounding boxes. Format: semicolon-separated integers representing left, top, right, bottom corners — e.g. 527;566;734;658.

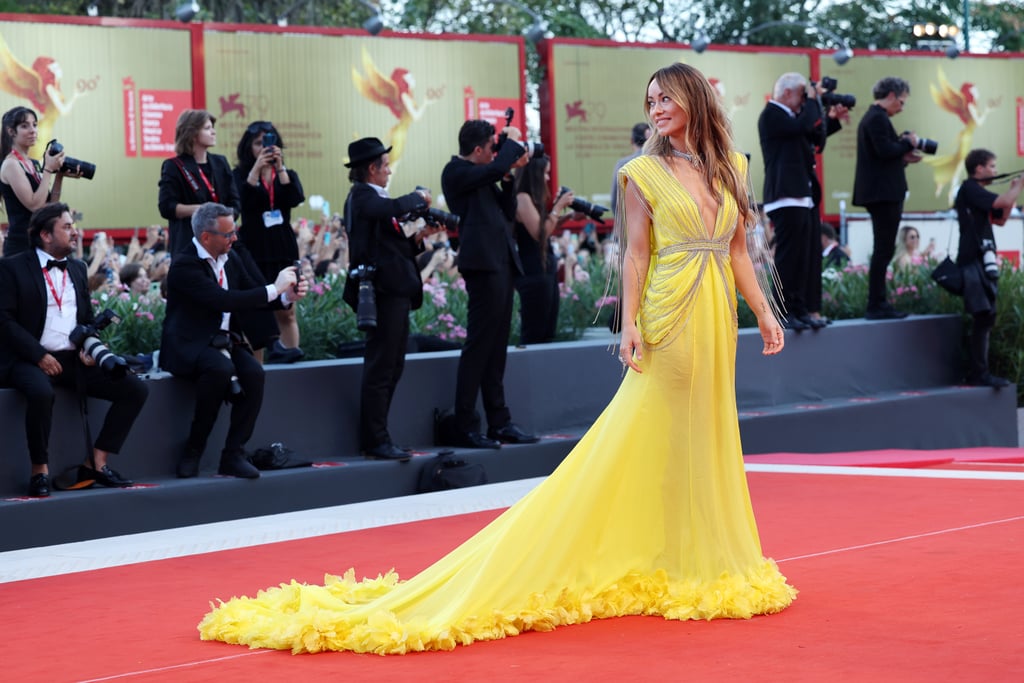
758;99;842;206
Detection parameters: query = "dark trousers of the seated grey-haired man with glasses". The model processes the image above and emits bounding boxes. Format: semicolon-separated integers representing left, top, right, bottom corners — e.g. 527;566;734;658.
186;344;263;455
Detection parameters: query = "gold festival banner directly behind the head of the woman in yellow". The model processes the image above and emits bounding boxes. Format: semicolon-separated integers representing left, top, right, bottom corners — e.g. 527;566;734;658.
548;39;810;206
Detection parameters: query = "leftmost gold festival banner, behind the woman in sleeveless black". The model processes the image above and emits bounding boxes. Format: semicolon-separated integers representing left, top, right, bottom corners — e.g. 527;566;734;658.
0;22;191;228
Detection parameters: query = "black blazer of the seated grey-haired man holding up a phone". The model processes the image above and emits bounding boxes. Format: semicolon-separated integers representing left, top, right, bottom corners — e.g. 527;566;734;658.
160;243;281;375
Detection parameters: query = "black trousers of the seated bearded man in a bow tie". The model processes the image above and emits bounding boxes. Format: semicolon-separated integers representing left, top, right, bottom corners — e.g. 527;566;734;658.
7;351;150;465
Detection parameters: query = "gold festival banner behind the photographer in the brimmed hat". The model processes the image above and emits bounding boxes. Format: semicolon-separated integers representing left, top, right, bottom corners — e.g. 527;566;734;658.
205;30;522;218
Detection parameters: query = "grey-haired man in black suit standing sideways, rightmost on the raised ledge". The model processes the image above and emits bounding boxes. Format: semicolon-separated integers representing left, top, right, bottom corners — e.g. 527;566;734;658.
853;76;922;321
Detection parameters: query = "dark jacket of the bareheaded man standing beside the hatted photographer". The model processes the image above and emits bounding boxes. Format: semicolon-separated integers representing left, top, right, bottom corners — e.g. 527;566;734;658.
441;140;526;274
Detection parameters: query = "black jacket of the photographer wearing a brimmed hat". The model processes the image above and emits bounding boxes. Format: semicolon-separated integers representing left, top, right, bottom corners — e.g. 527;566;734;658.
344;182;427;310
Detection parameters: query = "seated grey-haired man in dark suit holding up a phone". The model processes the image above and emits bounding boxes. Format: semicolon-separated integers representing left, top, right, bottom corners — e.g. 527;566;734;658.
160;202;308;479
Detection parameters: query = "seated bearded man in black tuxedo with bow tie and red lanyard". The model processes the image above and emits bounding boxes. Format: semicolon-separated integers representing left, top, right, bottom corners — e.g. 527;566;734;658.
0;203;148;498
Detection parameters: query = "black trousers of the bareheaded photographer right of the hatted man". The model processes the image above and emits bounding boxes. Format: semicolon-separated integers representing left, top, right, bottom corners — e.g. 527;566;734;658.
455;270;514;432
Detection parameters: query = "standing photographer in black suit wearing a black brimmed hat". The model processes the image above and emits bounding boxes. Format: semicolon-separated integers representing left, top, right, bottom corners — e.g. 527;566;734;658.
343;137;435;461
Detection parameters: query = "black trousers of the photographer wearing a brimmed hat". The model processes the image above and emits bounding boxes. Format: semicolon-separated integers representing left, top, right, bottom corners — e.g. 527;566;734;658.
359;292;411;450
